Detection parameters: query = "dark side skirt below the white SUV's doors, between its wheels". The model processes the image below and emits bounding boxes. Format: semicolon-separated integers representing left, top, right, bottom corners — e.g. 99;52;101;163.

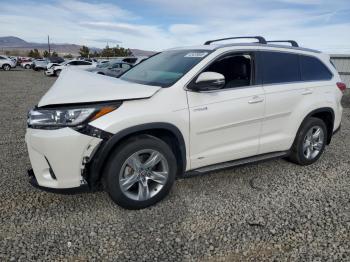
183;151;290;178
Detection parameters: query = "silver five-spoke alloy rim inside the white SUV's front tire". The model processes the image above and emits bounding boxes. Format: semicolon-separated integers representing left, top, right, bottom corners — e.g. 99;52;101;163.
119;149;169;201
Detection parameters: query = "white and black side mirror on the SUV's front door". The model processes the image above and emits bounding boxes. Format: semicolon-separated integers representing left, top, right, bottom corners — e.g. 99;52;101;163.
189;72;225;91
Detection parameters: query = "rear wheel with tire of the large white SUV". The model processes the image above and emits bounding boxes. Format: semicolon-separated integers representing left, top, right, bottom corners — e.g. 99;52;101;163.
289;117;328;166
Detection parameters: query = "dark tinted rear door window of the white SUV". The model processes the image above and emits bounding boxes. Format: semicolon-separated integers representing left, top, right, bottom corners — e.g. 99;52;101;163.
261;52;300;84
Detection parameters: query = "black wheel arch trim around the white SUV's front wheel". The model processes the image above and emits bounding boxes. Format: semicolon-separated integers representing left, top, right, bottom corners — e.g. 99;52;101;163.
84;123;187;190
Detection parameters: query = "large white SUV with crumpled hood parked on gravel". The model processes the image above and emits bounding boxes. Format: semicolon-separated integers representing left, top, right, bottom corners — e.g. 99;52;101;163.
26;37;345;209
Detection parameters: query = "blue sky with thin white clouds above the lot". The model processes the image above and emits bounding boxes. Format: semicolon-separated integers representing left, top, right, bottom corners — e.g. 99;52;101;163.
0;0;350;53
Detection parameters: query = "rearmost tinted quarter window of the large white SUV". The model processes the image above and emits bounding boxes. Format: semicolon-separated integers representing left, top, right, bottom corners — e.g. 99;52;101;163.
300;56;332;81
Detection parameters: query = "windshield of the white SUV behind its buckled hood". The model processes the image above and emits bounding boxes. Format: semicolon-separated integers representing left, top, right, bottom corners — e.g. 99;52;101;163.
120;50;210;87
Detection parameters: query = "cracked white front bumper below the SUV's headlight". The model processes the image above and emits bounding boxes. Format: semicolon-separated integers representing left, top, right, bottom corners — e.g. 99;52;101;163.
25;128;101;189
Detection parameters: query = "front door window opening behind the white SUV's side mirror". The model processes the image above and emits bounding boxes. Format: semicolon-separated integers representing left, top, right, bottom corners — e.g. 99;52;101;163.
204;53;253;89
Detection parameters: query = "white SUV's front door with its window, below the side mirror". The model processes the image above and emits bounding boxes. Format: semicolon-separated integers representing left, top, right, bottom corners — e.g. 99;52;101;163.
187;53;265;169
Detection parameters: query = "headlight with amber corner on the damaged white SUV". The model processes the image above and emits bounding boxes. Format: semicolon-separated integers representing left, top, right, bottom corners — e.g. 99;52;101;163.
27;104;120;129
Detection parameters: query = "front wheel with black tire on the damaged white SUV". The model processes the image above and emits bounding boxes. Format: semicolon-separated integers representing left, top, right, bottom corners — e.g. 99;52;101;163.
104;135;177;209
